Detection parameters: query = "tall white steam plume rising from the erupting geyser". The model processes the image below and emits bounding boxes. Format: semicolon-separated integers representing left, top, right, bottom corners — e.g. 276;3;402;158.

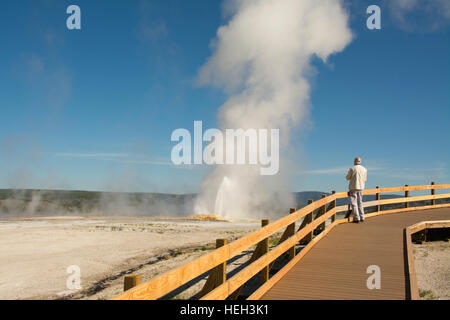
195;0;352;218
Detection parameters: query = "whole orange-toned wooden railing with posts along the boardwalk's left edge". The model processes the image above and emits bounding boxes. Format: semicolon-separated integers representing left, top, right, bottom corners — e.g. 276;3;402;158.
115;183;450;300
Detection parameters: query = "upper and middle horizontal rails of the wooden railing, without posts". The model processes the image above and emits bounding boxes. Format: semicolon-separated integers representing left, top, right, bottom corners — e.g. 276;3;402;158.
115;184;450;300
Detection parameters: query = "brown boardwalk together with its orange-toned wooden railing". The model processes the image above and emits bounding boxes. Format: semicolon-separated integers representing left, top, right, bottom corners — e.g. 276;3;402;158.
114;182;450;300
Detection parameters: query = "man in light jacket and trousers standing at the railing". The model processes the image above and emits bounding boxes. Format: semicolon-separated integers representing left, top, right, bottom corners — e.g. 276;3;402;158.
346;157;367;223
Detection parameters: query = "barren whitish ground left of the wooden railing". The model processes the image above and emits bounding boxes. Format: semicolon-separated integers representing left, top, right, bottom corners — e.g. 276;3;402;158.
0;217;259;299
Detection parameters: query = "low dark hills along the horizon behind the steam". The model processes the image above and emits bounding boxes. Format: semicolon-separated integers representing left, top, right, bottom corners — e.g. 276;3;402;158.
0;189;449;216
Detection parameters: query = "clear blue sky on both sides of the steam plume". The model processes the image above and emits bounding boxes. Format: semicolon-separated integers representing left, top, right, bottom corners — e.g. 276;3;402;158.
0;0;450;193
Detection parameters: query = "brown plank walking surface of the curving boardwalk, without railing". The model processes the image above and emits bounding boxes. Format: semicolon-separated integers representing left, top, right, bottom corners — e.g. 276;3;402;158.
261;208;450;300
